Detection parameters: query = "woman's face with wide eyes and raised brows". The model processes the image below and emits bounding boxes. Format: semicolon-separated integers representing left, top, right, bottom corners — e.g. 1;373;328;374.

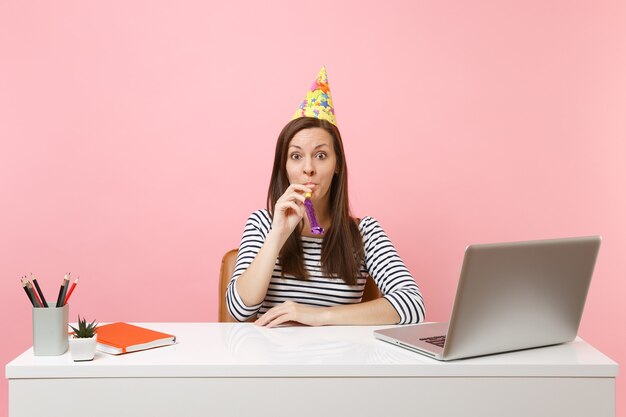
286;127;337;201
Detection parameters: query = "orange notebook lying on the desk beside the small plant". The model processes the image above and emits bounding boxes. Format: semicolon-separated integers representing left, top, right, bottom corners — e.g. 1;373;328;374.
96;322;176;355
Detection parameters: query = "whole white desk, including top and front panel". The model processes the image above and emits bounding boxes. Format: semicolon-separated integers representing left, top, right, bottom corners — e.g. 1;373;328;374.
6;323;618;417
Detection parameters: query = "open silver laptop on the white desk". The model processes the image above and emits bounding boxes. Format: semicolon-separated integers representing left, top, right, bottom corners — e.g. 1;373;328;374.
374;236;602;361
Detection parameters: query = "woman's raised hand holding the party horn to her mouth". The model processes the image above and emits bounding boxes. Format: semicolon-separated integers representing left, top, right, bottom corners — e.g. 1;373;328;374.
272;184;312;241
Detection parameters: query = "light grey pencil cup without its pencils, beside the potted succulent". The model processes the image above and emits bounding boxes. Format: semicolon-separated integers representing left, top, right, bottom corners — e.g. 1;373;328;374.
33;304;69;356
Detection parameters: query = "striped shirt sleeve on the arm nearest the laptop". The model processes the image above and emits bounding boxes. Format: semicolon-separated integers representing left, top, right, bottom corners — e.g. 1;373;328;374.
360;217;426;324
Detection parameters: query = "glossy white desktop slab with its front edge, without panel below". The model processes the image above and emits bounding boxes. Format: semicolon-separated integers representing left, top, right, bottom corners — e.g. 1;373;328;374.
6;323;618;379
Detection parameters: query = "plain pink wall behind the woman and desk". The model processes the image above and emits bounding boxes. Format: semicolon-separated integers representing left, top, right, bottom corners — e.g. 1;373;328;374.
0;0;626;415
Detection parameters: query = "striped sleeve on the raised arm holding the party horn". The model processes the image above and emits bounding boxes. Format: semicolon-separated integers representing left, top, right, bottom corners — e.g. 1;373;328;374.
226;210;271;321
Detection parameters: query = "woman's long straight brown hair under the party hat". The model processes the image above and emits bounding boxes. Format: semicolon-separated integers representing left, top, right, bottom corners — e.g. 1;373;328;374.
267;117;364;285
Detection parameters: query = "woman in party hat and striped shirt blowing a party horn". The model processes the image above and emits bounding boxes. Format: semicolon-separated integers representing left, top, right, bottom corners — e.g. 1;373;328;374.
226;68;425;327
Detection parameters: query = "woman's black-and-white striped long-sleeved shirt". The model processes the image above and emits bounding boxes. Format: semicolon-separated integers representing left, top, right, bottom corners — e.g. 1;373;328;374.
226;209;425;324
